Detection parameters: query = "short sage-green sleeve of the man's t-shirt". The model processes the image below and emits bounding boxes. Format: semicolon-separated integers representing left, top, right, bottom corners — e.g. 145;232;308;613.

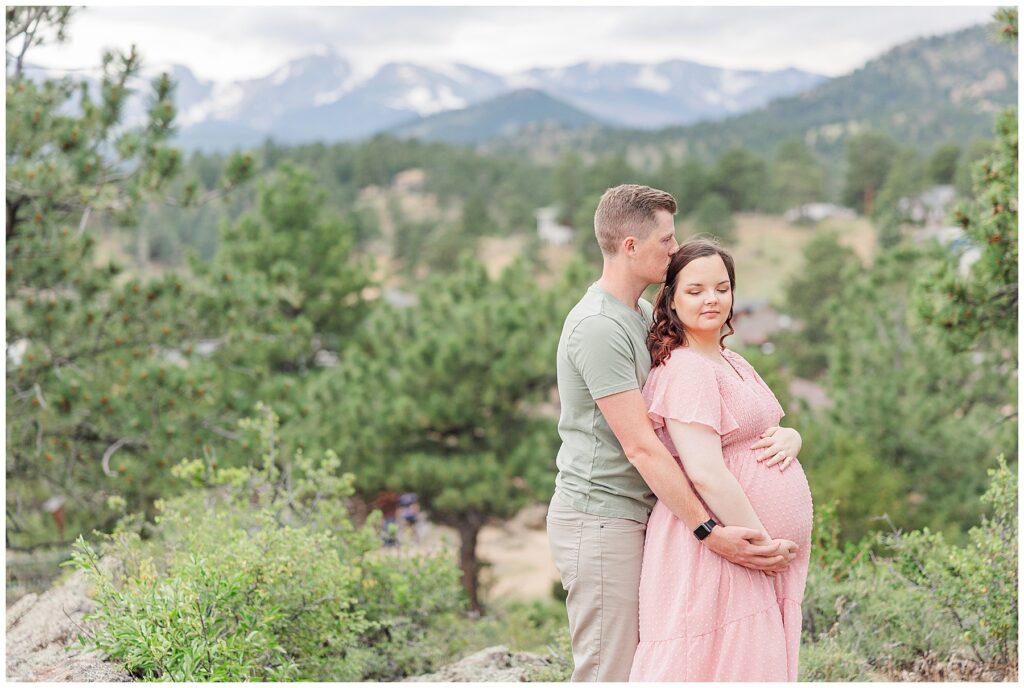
566;315;640;399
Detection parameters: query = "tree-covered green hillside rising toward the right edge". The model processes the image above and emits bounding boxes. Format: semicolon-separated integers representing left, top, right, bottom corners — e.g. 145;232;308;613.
484;21;1018;164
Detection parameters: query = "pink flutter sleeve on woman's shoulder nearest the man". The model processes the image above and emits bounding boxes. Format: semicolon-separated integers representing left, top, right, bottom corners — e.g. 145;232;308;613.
645;352;739;435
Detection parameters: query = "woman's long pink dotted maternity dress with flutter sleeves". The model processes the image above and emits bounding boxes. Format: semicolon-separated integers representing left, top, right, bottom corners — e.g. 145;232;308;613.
630;347;812;681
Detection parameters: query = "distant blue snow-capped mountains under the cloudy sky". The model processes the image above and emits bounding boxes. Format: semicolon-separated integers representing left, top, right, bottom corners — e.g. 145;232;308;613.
28;53;825;151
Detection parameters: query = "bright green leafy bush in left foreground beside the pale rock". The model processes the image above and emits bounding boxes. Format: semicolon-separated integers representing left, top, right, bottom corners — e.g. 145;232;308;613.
65;409;464;681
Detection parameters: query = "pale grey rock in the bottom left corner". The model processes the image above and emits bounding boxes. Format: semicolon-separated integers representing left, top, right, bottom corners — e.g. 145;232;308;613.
7;571;132;682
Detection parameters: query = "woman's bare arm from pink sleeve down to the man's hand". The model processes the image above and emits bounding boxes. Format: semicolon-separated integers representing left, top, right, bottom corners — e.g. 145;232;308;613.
666;419;771;541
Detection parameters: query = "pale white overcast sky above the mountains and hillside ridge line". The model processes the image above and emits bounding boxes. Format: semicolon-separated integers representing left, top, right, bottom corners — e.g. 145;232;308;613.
27;6;994;81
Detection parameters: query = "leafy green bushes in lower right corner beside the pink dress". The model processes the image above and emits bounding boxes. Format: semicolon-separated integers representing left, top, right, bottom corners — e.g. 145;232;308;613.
800;458;1017;681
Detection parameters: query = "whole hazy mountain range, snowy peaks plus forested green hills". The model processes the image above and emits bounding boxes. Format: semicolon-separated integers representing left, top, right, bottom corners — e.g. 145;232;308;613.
28;26;1018;160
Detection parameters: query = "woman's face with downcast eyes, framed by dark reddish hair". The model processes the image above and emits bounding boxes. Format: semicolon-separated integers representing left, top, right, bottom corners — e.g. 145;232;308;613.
672;254;732;337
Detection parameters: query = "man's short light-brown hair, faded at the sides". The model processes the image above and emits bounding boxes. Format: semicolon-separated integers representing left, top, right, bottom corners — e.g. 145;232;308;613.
594;184;678;256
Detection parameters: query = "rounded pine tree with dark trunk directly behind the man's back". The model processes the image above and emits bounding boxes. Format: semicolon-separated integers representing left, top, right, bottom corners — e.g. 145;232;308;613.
304;259;567;609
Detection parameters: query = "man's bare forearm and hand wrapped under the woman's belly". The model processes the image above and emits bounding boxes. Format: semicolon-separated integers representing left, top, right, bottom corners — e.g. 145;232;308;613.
596;389;797;572
